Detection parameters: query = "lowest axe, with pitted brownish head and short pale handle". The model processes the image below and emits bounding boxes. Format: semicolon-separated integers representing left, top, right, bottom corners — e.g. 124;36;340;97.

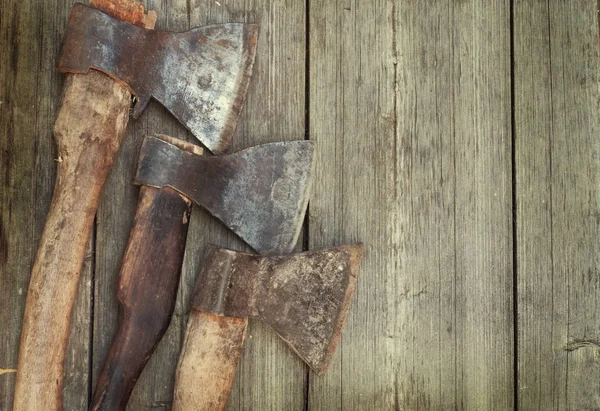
172;244;363;411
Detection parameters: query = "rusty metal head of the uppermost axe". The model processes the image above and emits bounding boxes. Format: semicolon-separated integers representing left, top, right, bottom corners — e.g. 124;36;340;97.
58;4;258;153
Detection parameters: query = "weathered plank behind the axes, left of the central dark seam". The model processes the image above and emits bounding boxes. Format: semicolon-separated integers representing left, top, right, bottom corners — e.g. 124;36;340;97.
94;0;306;410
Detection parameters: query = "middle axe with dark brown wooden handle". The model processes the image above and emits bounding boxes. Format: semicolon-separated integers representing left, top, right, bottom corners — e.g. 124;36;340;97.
91;135;313;411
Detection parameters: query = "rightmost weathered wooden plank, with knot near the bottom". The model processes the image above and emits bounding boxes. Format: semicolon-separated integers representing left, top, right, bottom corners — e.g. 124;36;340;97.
514;0;600;410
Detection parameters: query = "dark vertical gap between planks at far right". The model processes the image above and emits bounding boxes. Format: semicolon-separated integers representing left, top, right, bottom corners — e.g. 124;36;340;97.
509;0;519;410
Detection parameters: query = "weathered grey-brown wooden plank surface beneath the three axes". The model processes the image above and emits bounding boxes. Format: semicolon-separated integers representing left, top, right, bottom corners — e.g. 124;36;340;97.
0;0;600;411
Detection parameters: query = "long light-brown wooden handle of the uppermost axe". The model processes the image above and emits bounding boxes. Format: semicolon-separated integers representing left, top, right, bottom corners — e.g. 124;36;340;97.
13;0;155;411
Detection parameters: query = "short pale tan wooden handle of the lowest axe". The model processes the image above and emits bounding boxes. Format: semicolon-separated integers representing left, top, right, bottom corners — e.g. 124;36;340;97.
172;309;248;411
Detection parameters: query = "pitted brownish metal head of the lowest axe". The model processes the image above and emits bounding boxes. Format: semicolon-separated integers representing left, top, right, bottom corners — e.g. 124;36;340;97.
192;244;363;375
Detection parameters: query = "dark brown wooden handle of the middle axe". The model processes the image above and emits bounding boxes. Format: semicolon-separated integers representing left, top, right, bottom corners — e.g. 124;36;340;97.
91;186;191;411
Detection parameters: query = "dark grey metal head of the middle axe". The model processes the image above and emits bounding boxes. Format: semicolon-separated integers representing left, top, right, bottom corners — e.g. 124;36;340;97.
135;137;314;254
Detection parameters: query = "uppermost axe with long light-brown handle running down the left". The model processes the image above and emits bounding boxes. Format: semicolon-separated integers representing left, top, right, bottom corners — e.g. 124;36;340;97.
13;0;256;411
